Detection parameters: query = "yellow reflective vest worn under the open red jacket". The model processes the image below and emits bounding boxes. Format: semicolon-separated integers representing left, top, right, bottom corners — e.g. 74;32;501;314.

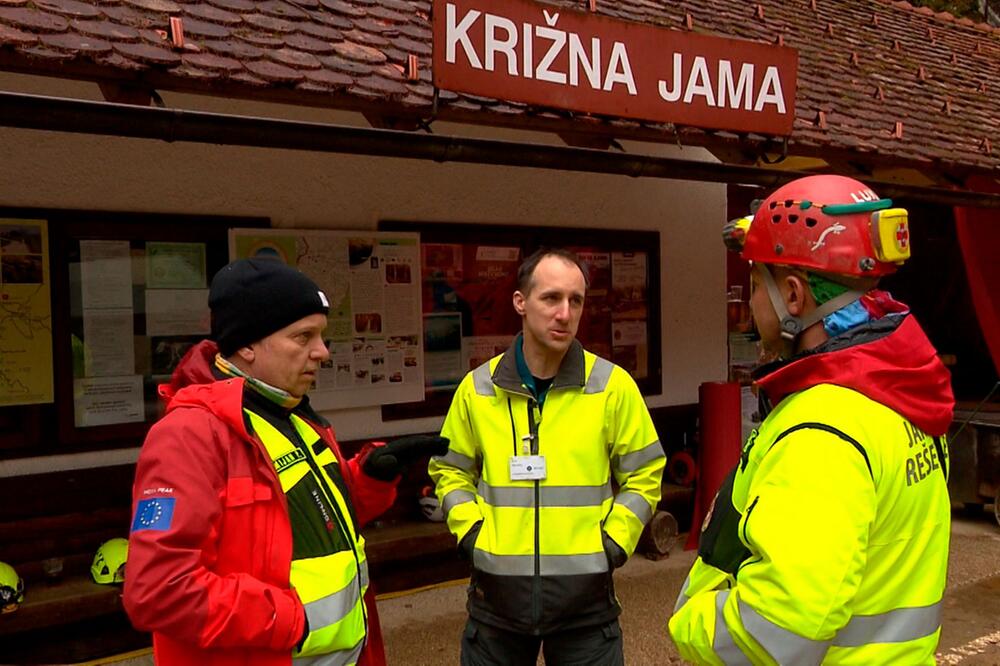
244;410;368;666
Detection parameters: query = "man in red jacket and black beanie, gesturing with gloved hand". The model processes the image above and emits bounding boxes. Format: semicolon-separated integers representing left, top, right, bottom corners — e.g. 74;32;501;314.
124;258;447;666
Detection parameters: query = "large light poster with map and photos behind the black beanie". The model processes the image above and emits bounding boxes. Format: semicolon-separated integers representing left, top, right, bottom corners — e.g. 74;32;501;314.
229;229;425;409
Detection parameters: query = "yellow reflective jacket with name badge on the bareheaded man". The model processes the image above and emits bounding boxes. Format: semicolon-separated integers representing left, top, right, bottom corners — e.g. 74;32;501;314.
429;337;665;634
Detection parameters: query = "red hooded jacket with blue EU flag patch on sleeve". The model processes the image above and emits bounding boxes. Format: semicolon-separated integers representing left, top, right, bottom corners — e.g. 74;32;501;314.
123;341;396;666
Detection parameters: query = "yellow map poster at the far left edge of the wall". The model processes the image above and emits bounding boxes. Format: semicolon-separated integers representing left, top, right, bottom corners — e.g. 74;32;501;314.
0;219;53;406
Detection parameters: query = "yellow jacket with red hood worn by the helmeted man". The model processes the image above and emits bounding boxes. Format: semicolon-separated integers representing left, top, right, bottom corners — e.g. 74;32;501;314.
669;318;953;665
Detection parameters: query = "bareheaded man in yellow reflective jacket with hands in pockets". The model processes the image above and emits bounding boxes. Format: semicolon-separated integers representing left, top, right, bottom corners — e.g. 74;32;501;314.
429;250;664;666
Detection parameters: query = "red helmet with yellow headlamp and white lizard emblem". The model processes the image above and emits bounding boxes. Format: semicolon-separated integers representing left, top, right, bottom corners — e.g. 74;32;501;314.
724;175;910;277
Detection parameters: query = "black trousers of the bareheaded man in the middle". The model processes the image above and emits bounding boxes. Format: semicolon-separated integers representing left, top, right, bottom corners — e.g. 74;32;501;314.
461;617;625;666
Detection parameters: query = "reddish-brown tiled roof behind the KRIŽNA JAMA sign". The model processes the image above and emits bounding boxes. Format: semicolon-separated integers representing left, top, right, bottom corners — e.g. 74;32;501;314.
0;0;1000;170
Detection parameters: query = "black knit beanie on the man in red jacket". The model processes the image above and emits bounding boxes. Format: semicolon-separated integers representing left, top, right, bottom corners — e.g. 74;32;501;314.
208;257;330;356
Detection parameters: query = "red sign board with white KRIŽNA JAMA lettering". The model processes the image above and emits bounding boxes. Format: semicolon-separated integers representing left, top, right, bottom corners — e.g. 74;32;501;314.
433;0;798;134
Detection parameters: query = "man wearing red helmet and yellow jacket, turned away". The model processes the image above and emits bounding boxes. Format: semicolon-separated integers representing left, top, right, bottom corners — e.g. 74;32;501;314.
670;176;954;664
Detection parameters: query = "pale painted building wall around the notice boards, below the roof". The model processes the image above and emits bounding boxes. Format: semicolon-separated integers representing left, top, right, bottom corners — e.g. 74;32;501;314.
0;74;726;476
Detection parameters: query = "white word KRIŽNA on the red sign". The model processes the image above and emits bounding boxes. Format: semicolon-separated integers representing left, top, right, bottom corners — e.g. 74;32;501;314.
445;2;636;95
